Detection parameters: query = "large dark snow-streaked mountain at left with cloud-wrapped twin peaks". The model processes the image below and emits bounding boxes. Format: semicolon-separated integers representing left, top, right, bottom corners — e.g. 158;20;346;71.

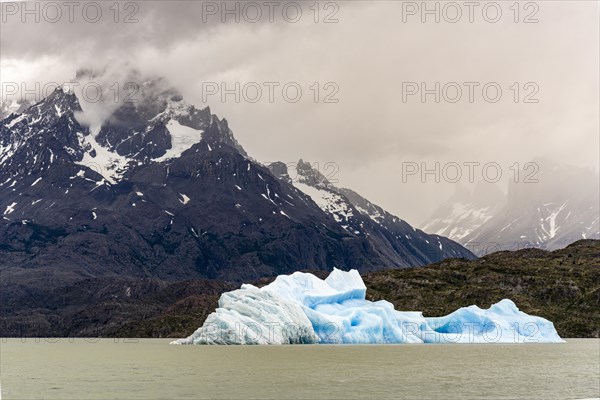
0;76;473;291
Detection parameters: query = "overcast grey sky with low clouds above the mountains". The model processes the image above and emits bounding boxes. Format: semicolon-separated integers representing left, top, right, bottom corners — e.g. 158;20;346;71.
0;1;600;225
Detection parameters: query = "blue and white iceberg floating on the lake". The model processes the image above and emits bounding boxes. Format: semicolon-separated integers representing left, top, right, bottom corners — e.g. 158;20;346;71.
172;269;564;345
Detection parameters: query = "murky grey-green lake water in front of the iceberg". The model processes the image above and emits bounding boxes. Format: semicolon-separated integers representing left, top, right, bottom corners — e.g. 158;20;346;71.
0;339;600;400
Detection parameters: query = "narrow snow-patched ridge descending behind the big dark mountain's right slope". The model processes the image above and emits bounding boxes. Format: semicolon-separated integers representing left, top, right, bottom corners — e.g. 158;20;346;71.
269;160;474;267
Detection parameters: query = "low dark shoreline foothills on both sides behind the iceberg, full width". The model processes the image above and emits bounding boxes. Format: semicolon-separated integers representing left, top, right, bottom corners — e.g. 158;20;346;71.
0;240;600;337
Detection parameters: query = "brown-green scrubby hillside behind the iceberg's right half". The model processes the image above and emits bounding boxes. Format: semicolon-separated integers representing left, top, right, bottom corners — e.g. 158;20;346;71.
364;240;600;337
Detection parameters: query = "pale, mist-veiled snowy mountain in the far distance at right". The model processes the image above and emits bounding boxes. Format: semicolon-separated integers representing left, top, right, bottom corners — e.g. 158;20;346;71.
424;158;600;255
